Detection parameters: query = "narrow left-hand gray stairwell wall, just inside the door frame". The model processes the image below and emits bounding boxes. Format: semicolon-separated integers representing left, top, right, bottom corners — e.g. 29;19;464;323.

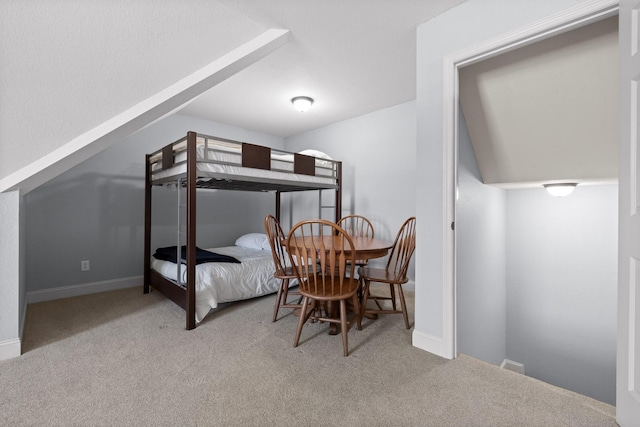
456;113;507;365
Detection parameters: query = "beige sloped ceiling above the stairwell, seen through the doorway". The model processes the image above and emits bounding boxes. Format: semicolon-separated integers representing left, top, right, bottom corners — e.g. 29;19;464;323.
459;16;618;188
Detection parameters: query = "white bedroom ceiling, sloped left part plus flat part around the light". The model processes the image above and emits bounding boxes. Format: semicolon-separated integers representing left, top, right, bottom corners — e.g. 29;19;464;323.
0;0;464;187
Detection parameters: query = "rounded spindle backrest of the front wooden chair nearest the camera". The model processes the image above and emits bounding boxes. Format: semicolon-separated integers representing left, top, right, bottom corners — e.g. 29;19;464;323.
287;219;356;297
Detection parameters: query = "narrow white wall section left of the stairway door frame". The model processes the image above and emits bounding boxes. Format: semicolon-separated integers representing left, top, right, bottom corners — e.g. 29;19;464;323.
414;0;600;357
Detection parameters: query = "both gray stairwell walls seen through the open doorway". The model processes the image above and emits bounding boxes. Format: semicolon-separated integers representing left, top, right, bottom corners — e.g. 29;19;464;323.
456;108;618;404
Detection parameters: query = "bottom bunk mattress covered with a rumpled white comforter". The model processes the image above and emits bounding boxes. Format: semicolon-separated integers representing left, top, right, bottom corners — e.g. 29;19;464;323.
151;246;284;322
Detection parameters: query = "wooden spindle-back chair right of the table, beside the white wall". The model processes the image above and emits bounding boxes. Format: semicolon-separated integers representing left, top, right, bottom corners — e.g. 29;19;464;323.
358;217;416;329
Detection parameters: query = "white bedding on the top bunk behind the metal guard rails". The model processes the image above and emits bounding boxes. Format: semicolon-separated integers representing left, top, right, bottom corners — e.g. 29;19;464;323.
153;137;336;185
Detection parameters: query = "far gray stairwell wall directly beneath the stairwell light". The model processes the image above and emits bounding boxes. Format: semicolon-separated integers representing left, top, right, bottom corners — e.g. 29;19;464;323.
507;186;618;404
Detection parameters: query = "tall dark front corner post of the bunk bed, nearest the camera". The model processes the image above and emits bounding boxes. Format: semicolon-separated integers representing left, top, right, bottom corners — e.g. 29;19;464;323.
186;132;197;329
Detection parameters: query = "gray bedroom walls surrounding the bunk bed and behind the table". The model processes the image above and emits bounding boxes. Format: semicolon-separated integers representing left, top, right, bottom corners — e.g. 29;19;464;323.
26;102;415;291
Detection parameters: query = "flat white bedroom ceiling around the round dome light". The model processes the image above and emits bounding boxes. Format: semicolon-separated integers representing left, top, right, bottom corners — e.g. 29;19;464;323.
179;0;464;137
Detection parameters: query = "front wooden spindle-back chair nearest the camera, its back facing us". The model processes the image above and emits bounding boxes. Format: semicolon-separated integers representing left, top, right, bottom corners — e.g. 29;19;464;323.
287;219;361;356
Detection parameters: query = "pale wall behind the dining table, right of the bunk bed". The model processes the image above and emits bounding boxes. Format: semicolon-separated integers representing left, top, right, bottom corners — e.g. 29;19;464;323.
285;101;421;272
